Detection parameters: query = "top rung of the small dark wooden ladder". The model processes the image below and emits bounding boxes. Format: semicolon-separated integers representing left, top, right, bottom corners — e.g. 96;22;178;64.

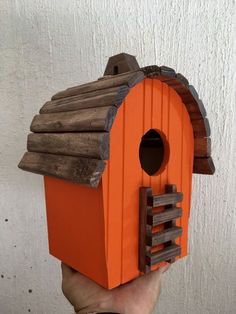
148;192;183;207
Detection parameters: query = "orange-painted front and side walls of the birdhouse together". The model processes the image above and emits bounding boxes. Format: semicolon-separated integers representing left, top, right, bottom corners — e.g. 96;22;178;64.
45;79;193;289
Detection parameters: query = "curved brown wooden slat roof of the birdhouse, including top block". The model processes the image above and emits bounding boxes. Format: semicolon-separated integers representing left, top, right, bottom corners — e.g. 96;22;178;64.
19;54;215;187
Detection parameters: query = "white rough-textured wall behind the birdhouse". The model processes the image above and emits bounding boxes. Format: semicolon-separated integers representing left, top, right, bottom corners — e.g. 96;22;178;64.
0;0;236;314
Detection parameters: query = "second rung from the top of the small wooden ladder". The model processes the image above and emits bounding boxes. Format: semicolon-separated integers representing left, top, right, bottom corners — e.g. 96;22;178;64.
147;207;183;227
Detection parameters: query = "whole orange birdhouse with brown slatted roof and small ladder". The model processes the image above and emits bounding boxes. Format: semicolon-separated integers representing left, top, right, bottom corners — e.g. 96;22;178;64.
19;53;214;289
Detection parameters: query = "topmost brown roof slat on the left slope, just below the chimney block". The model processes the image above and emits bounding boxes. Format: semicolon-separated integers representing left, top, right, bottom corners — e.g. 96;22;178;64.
52;71;145;100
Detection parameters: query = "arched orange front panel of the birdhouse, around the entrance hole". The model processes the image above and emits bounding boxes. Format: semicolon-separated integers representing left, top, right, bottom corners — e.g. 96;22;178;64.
102;79;194;286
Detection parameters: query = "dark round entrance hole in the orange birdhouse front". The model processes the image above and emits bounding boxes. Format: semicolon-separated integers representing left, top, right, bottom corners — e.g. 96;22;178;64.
139;129;166;176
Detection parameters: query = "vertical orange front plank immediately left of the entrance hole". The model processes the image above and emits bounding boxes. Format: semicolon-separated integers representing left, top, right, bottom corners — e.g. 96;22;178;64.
122;88;144;283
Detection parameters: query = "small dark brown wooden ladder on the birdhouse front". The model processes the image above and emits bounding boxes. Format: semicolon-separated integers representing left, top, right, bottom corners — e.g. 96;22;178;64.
139;184;183;273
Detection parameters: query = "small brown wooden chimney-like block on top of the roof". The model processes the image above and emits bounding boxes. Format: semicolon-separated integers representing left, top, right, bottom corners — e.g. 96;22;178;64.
104;53;139;75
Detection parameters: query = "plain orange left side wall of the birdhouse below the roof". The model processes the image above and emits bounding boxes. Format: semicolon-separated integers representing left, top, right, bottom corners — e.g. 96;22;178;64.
44;176;108;287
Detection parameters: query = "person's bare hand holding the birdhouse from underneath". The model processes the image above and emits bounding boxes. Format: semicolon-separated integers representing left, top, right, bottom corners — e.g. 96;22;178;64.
61;263;169;314
